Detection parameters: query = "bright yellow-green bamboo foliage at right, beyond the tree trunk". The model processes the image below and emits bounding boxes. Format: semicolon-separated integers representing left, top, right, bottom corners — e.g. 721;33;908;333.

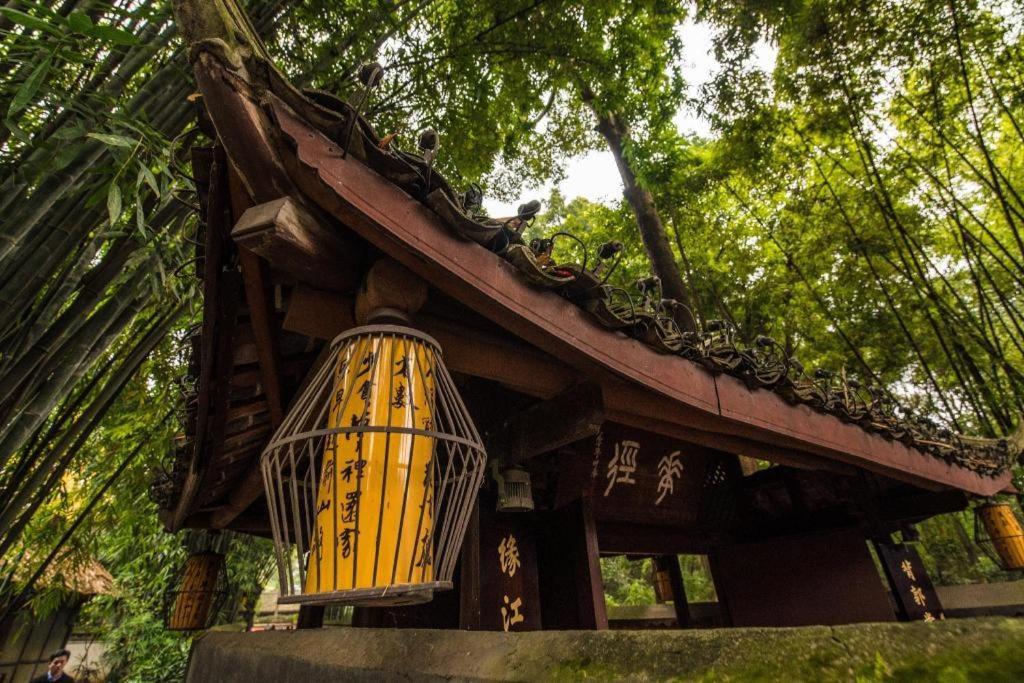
688;0;1024;434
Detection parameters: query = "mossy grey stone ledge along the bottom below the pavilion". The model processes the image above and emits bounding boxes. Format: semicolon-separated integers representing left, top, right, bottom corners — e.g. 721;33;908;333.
187;618;1024;683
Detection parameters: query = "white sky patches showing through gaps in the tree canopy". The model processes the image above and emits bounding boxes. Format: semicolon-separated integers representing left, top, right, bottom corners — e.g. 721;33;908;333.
483;19;776;216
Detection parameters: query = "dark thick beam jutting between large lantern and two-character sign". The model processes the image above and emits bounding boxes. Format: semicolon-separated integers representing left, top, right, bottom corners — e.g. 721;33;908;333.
487;383;604;465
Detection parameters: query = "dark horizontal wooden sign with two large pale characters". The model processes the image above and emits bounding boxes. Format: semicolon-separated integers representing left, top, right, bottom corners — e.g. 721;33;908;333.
559;422;719;526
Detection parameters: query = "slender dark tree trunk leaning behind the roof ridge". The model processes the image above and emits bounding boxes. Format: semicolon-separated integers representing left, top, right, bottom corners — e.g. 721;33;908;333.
583;94;694;331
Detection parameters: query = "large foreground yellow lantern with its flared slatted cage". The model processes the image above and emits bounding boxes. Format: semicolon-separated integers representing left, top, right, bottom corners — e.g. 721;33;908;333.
260;325;486;605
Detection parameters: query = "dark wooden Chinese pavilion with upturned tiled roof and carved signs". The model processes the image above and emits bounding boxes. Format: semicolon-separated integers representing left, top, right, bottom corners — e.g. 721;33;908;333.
157;0;1012;631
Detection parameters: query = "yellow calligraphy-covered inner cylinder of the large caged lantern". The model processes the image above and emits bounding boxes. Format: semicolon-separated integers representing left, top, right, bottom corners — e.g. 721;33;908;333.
303;337;434;594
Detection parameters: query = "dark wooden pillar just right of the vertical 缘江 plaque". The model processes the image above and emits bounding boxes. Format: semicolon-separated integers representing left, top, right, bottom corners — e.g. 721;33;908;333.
539;497;608;630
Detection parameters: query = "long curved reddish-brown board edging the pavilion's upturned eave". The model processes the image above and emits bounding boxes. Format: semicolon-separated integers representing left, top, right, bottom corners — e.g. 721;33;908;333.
184;46;1010;496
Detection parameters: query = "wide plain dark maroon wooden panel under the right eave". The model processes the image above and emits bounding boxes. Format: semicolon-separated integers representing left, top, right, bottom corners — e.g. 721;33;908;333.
710;529;895;626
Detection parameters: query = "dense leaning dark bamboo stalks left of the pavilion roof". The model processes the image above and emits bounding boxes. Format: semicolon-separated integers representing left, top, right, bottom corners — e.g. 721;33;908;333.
0;0;294;618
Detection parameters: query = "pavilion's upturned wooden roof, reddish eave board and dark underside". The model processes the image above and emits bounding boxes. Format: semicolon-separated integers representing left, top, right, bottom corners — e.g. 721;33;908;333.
157;0;1010;531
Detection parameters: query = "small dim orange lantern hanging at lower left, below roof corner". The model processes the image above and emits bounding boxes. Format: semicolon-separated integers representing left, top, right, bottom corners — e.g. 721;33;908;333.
164;550;228;631
